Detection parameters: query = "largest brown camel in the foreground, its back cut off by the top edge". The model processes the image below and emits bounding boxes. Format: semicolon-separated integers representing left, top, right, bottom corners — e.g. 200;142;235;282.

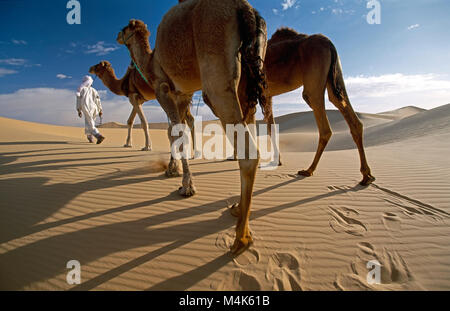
117;0;267;255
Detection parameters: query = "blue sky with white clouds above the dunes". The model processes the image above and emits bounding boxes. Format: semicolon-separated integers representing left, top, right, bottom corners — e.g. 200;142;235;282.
0;0;450;125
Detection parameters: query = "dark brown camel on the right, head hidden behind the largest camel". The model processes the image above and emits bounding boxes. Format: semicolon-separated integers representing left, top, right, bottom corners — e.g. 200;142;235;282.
265;28;375;185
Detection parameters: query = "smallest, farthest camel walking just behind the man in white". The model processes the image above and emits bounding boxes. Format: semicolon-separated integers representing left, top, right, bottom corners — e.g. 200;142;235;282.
89;61;195;151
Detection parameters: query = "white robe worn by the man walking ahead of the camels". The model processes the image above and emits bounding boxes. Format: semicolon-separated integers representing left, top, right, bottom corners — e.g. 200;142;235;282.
77;86;102;136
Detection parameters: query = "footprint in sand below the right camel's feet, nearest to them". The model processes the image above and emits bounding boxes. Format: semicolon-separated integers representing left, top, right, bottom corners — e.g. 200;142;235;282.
329;206;367;236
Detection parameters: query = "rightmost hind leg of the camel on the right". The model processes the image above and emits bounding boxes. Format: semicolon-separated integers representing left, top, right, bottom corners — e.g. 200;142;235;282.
327;85;375;186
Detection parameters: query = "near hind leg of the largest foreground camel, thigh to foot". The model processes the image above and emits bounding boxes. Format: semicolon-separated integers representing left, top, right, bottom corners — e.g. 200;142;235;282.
194;1;267;255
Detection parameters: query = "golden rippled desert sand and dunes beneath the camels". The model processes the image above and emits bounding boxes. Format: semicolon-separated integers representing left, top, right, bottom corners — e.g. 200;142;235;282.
0;105;450;290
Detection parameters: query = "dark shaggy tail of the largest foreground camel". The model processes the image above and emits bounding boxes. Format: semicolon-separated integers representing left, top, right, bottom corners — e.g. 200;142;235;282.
238;6;271;119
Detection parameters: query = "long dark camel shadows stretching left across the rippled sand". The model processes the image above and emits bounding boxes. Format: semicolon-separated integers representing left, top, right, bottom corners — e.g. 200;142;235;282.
0;157;364;290
